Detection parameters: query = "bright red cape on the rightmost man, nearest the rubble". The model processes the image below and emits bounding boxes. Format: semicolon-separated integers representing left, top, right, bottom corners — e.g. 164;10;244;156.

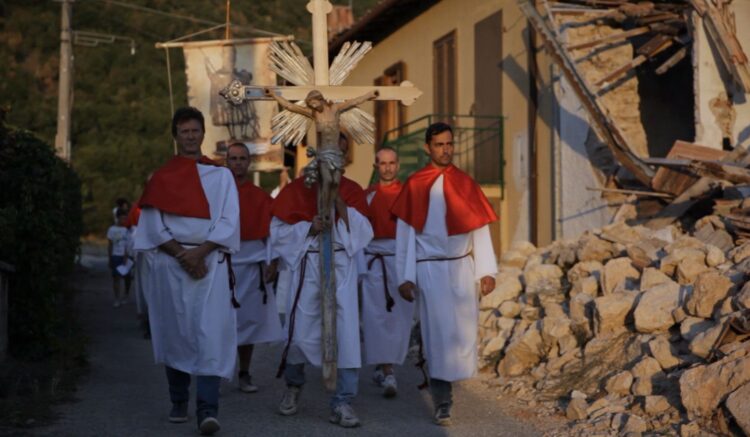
391;164;497;235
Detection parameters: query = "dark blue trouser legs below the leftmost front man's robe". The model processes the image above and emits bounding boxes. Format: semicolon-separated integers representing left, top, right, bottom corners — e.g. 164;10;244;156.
164;366;221;422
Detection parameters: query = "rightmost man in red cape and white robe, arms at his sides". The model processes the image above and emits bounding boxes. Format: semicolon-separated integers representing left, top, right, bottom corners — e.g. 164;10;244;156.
391;123;497;426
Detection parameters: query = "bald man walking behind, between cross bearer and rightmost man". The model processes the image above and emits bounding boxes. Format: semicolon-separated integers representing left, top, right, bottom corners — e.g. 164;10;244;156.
362;147;414;398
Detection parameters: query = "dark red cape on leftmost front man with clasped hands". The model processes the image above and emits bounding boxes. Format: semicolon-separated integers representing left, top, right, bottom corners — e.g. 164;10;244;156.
138;155;218;219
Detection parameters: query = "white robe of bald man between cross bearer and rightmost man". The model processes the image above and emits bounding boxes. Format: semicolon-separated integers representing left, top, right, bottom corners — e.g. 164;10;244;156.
362;193;414;364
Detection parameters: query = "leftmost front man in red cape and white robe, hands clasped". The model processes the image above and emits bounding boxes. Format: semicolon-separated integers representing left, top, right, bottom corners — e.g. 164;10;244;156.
135;107;240;435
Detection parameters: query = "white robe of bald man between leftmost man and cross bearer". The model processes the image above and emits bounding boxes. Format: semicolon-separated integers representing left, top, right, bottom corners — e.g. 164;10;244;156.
232;240;285;345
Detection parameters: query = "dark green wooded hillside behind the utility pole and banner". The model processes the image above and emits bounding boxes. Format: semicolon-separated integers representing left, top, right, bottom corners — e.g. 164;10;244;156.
0;0;377;233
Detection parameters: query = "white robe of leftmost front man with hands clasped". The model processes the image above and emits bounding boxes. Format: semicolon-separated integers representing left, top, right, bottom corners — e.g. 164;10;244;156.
135;164;240;379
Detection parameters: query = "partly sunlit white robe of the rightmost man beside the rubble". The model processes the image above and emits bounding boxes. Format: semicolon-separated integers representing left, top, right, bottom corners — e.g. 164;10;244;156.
396;175;497;381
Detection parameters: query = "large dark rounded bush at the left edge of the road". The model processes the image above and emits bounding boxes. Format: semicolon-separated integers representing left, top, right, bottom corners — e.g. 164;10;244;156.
0;117;83;359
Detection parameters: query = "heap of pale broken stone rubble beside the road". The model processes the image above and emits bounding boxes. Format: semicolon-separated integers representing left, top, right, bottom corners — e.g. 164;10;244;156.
479;220;750;436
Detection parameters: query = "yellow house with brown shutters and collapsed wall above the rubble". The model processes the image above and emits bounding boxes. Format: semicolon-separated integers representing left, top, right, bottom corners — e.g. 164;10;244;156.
330;0;750;252
